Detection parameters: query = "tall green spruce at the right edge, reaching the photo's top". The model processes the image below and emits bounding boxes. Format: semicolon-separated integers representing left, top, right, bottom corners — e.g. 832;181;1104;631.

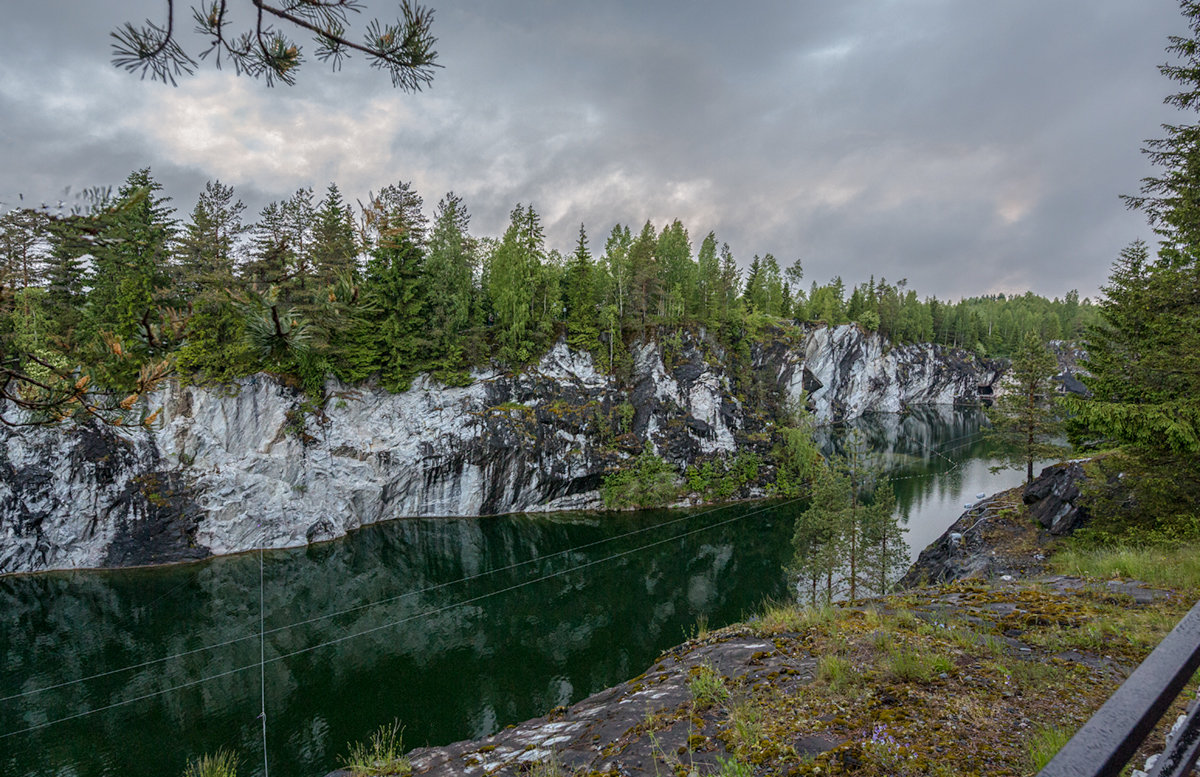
1069;0;1200;532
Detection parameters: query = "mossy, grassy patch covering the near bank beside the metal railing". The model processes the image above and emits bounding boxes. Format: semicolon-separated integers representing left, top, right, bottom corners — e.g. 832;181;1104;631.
659;578;1200;776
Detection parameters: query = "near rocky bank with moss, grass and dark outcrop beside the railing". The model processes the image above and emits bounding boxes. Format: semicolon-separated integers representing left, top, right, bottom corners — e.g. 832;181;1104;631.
333;465;1196;777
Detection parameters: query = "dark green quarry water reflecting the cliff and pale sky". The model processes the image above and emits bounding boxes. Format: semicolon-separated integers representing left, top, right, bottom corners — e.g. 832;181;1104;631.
0;402;1020;777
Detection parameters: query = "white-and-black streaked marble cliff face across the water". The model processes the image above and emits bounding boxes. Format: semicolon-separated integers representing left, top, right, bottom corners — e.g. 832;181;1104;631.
0;326;998;574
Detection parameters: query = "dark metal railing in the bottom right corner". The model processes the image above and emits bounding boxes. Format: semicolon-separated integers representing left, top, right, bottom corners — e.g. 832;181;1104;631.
1038;602;1200;777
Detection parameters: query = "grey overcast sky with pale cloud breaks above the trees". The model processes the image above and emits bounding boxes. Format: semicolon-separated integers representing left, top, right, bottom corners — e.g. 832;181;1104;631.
0;0;1194;299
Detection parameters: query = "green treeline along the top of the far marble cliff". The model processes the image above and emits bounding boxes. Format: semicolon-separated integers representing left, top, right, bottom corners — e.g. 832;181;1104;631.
0;169;1094;407
